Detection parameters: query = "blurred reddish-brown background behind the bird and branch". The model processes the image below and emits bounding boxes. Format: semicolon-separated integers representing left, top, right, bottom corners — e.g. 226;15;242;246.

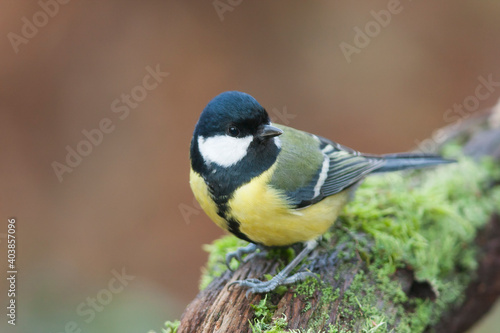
0;0;500;332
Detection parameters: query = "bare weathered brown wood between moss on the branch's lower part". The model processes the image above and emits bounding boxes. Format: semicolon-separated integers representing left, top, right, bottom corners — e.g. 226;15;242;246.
178;215;500;333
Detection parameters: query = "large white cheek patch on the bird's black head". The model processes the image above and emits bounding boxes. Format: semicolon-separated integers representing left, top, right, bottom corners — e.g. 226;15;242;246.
198;135;253;168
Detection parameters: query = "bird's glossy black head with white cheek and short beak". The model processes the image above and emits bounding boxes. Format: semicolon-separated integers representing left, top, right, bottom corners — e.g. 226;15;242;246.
191;91;283;173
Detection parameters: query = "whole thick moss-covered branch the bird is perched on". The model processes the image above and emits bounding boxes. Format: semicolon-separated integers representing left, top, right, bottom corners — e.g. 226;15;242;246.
177;107;500;333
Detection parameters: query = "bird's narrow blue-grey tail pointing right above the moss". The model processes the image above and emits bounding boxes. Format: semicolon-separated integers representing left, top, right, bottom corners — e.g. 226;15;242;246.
373;153;456;172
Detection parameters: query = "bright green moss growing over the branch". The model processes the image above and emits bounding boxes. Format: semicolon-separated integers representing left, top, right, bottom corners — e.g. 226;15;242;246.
197;152;500;332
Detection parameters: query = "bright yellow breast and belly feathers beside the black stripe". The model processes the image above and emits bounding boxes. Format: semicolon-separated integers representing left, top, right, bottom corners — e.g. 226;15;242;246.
191;167;348;246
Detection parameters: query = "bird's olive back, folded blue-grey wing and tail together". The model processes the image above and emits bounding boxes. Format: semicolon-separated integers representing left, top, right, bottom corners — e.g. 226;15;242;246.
273;126;453;208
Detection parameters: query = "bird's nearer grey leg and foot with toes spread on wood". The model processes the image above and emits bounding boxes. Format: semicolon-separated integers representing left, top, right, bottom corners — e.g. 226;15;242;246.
229;240;318;296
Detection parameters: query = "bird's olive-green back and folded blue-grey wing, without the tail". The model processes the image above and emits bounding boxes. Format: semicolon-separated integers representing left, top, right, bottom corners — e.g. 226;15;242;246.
270;126;384;208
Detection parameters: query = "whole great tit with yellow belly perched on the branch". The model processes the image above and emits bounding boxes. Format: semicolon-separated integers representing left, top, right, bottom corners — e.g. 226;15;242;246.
189;91;453;296
